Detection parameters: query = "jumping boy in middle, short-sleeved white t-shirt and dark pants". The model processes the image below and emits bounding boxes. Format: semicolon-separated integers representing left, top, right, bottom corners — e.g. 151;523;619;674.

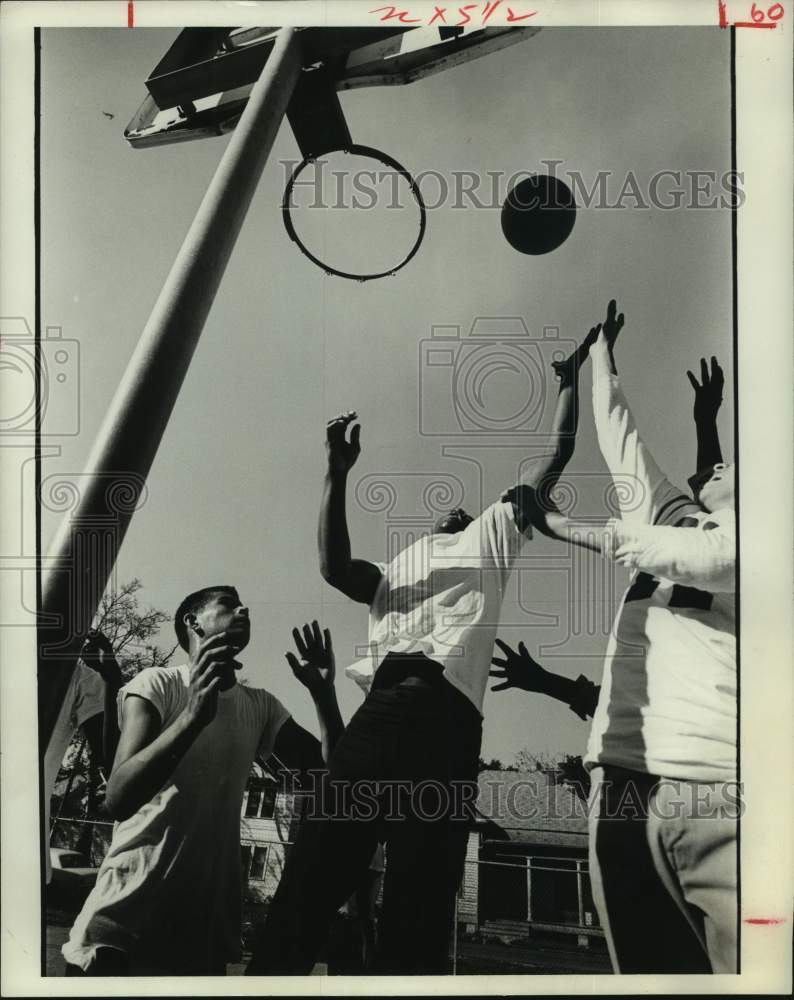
248;322;595;975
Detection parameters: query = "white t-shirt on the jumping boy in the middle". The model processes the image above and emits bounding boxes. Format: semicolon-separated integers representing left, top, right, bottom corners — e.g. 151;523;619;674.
345;501;526;712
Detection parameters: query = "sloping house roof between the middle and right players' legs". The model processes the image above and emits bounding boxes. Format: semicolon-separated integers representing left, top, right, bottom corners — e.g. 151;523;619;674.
477;771;587;847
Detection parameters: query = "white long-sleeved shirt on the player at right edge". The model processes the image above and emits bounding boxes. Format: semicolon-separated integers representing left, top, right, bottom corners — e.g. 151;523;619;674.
585;376;737;782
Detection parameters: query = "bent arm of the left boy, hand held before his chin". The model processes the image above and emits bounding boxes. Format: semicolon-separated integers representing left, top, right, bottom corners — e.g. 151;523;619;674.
105;632;236;820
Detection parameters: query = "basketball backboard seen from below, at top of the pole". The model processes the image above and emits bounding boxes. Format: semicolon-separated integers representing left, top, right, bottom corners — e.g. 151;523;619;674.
124;27;540;156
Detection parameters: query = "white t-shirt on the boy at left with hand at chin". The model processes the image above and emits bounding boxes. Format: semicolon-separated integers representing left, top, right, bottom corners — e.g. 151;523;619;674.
62;665;289;969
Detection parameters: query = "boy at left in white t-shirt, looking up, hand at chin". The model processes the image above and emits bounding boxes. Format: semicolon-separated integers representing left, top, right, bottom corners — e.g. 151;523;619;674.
62;586;343;976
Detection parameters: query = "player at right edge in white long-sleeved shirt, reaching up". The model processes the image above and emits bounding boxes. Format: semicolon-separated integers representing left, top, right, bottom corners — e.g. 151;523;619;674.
520;301;738;973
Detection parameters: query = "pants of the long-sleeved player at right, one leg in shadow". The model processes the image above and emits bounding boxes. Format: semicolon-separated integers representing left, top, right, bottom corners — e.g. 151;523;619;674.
590;766;738;973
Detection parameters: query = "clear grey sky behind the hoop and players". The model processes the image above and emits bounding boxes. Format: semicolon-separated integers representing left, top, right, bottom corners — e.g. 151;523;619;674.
42;28;733;760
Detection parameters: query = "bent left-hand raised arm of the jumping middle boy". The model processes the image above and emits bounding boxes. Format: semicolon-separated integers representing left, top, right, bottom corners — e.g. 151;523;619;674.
317;410;381;604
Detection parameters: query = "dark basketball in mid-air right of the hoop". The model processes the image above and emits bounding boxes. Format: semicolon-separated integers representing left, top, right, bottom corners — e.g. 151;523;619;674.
502;174;576;256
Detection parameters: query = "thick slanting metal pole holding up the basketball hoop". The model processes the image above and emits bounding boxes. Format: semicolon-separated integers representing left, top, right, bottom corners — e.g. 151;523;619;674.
38;28;301;753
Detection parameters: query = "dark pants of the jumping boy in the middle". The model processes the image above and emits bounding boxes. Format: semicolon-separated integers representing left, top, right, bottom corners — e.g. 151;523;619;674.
247;654;482;975
